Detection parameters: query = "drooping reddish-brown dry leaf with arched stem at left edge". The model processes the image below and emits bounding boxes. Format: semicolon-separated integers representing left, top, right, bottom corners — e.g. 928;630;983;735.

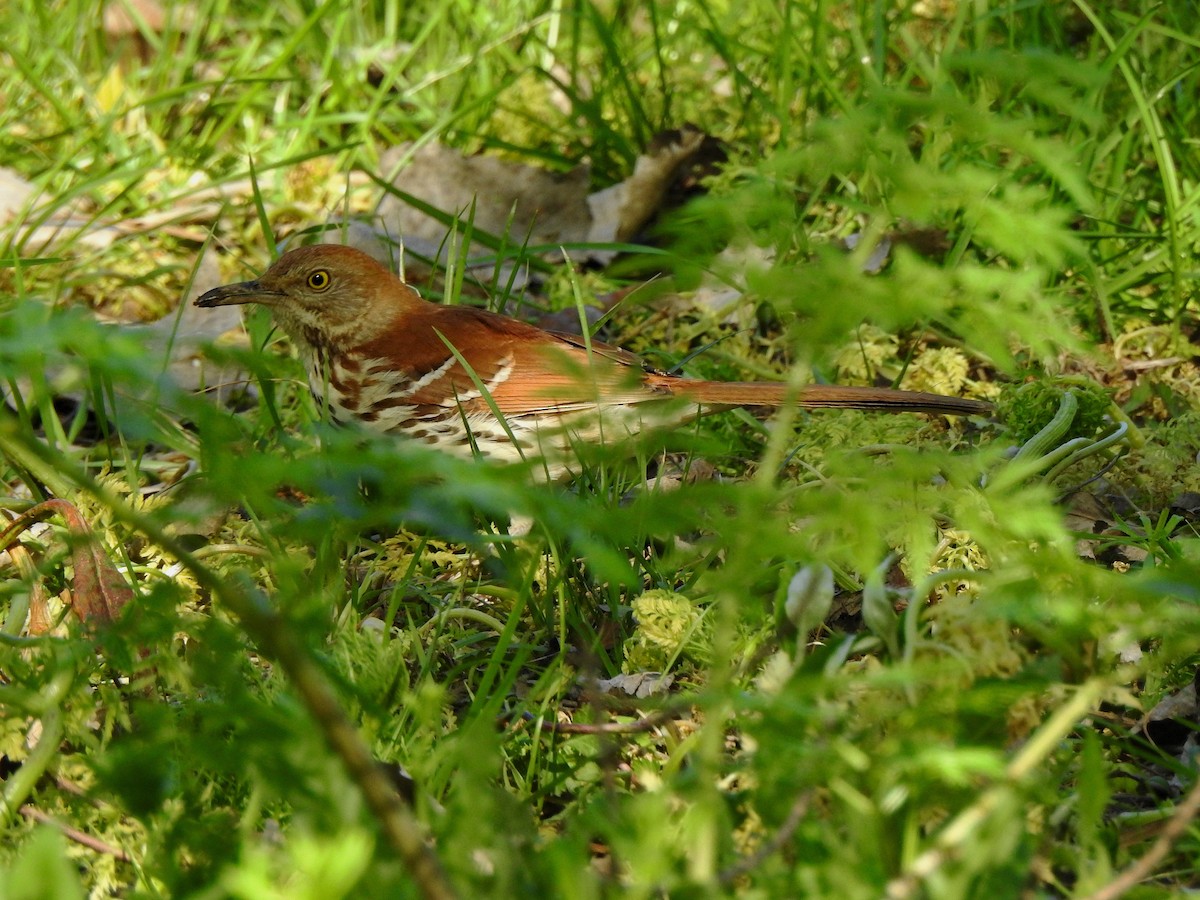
0;499;133;624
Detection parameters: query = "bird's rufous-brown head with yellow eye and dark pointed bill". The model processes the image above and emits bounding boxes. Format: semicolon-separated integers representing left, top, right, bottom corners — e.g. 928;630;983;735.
196;244;421;343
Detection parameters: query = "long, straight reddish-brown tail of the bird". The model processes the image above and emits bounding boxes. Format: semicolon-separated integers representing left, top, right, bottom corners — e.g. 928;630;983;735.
670;379;992;415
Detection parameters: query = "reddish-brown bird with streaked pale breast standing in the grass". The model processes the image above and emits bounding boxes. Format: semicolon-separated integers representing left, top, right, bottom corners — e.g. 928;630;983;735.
196;245;991;480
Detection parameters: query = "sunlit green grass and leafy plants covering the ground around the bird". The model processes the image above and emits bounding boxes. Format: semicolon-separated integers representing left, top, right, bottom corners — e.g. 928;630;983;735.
0;0;1200;898
